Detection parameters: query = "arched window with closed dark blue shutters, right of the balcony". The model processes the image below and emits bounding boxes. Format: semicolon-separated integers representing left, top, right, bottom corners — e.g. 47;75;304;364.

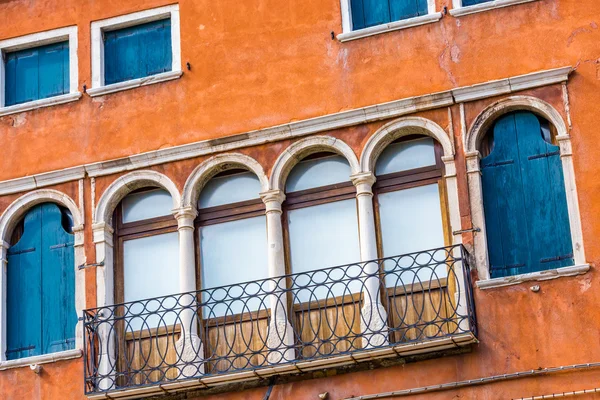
480;111;574;278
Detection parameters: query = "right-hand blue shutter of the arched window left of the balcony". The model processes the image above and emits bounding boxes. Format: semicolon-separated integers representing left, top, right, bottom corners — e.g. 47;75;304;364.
41;204;77;353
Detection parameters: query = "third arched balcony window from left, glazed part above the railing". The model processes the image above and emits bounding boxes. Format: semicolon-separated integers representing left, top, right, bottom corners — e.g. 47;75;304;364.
285;153;360;280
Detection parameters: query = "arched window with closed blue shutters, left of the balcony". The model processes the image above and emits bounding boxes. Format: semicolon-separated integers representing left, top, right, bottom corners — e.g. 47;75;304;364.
6;203;77;360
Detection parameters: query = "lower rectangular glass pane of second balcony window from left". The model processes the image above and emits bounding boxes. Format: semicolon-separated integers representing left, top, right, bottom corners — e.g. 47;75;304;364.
199;216;269;318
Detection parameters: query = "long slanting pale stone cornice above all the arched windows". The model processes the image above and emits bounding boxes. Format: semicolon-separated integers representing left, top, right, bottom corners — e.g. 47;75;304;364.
0;67;572;195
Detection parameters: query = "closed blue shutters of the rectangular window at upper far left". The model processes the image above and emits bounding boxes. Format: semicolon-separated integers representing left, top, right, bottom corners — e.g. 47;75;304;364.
4;41;70;106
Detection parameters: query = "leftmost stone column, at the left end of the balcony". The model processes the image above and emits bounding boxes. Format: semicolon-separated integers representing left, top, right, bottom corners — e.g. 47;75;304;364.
92;222;117;391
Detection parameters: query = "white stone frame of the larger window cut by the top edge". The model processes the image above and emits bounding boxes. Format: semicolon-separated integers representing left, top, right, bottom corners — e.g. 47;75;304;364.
337;0;443;42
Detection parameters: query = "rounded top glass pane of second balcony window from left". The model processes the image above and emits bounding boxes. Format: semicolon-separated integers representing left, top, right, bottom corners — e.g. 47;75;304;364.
198;172;261;208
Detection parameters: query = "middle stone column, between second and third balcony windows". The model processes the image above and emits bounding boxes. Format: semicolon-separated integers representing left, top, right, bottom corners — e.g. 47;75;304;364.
260;190;296;364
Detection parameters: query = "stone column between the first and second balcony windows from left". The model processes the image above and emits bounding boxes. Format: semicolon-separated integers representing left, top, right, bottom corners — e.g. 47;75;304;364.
173;207;204;378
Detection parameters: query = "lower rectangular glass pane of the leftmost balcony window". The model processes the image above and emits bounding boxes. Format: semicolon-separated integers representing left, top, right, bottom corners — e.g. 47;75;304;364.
123;232;179;330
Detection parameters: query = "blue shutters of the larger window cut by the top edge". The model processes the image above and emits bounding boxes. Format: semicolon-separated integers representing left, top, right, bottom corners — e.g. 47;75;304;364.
350;0;427;30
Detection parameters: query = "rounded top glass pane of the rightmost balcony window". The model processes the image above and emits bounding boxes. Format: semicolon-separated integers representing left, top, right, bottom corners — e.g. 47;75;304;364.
375;138;435;175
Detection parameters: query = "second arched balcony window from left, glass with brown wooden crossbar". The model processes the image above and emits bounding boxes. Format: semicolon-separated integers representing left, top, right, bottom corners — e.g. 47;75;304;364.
197;169;268;312
